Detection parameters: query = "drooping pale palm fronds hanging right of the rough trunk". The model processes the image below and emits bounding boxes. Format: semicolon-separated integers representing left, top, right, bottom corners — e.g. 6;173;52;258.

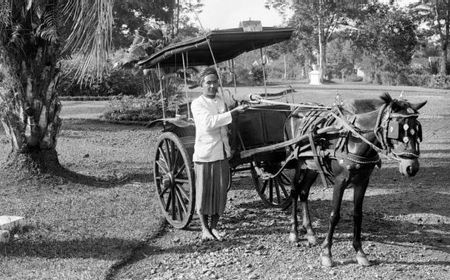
63;0;114;81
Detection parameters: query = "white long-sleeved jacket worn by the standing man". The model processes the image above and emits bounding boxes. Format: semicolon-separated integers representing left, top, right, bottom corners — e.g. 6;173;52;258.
191;95;232;162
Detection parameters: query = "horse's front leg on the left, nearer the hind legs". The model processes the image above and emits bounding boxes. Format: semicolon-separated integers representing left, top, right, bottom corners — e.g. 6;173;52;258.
320;176;348;267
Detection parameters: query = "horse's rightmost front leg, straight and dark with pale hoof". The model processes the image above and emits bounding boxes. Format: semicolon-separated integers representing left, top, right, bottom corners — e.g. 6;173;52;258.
353;172;370;266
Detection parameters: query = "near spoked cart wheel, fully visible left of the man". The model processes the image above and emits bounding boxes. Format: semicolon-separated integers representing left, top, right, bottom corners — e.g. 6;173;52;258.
153;132;195;229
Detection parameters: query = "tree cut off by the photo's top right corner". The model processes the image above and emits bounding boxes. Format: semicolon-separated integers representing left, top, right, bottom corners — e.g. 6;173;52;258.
409;0;450;75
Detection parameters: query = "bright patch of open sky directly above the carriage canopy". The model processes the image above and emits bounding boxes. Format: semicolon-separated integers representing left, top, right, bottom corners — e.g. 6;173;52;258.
198;0;283;30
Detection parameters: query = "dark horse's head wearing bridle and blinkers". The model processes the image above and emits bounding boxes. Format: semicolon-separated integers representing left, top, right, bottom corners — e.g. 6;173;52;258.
375;93;427;177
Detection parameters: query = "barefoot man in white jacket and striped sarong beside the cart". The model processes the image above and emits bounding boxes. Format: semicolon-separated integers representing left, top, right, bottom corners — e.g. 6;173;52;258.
191;67;247;241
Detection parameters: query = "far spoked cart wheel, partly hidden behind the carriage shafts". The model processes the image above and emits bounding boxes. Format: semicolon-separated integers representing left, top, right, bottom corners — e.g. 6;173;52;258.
251;162;295;209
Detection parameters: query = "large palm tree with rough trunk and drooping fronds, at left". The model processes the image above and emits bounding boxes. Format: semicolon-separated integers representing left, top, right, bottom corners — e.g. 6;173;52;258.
0;0;114;174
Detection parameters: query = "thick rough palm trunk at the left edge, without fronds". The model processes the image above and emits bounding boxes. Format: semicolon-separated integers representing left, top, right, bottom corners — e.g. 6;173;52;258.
0;43;61;174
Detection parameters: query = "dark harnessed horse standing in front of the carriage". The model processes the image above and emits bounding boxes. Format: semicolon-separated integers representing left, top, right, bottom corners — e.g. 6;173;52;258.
287;93;426;267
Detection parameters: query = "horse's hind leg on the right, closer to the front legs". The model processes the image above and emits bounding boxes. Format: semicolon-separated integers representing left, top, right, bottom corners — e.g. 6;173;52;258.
299;169;317;245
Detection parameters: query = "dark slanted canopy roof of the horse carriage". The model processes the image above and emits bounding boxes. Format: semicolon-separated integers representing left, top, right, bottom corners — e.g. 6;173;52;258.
138;27;293;68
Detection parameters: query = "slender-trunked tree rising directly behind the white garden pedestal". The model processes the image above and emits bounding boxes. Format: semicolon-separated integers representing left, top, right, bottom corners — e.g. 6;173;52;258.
266;0;367;81
